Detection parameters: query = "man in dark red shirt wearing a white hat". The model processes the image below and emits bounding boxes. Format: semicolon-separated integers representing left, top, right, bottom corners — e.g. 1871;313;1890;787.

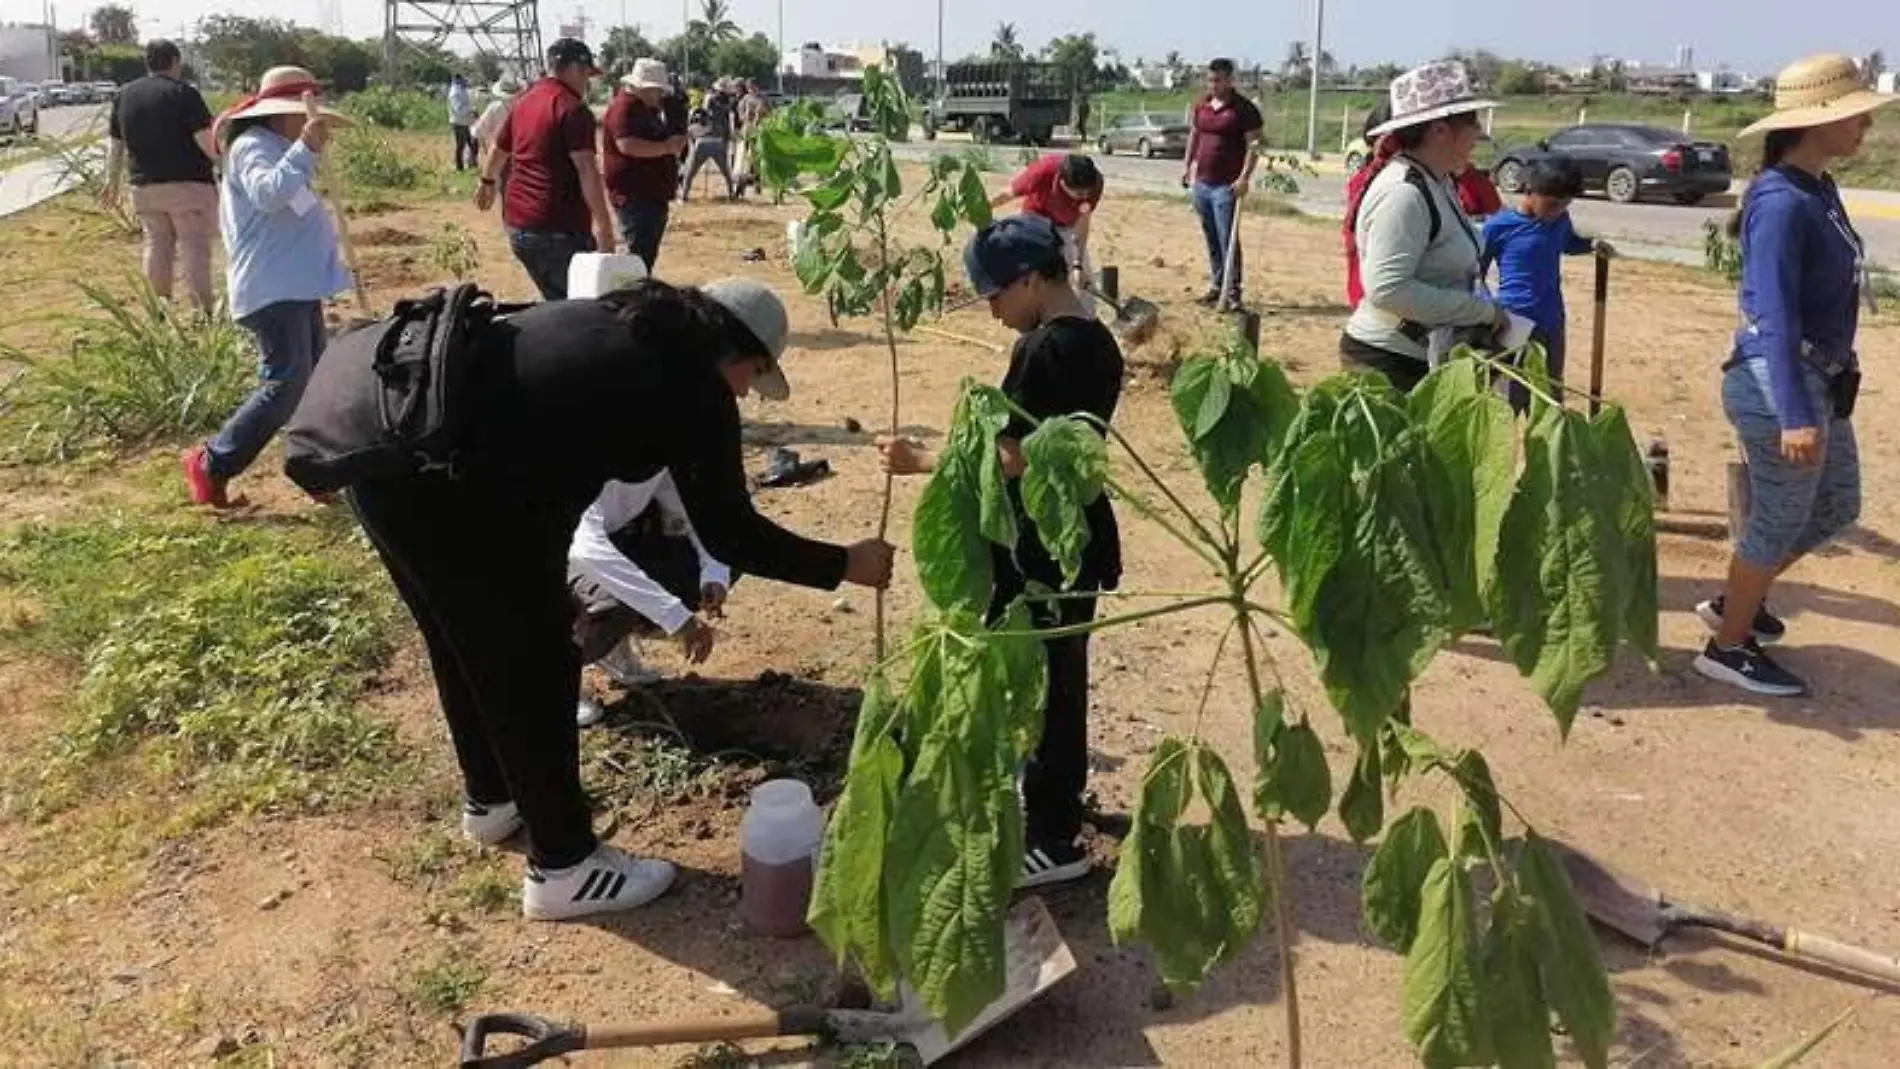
600;59;686;272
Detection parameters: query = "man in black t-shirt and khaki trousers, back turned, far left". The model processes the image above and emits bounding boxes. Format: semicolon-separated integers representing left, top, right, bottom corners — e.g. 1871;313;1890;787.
101;40;219;311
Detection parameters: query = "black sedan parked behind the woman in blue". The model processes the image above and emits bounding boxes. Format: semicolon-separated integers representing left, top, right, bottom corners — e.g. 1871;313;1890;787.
1492;123;1735;205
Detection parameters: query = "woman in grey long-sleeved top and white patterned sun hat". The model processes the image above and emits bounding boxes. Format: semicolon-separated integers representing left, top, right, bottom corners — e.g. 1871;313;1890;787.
1340;61;1511;393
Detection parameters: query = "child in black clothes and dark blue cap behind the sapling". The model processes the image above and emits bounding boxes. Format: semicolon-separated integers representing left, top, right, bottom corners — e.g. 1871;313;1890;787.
878;215;1123;889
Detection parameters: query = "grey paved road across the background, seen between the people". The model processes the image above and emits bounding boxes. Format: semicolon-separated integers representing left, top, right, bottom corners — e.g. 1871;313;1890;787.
899;139;1900;270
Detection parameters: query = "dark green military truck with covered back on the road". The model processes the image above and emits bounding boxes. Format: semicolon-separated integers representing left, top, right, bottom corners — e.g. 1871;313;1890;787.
923;61;1074;144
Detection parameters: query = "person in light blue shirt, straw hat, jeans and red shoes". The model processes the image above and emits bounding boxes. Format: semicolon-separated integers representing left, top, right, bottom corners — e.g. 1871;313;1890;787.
184;66;350;509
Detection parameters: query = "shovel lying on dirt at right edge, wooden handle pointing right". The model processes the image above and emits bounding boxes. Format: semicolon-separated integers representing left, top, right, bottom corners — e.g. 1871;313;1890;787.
1552;843;1900;984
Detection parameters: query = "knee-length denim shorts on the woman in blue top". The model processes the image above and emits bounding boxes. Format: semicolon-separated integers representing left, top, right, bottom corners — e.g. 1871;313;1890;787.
1721;359;1860;568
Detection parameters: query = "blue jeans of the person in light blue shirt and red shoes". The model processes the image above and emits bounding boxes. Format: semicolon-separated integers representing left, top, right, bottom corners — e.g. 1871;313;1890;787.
205;300;325;478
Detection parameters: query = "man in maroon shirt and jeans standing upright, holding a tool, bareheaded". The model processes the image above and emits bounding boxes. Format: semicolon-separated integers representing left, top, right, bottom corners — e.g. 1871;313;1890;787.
1182;59;1265;308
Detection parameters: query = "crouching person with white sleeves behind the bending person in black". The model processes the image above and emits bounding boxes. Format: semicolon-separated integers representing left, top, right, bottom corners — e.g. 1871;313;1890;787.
568;471;732;727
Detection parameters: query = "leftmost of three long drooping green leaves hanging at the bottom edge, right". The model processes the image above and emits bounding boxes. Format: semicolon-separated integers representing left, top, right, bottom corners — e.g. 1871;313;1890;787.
1404;856;1492;1069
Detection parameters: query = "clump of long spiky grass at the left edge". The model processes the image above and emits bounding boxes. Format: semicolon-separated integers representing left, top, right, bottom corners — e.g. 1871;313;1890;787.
0;279;257;461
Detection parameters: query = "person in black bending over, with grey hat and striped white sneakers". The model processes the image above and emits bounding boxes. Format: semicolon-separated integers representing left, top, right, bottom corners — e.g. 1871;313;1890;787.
350;279;893;921
